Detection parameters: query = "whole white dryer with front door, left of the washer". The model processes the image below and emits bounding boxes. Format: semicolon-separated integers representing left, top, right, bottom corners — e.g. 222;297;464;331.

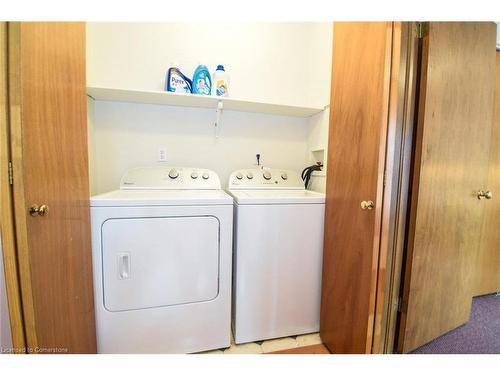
91;166;233;353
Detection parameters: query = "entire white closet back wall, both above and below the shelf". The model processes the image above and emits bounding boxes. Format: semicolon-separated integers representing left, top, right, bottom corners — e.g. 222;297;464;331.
87;23;332;194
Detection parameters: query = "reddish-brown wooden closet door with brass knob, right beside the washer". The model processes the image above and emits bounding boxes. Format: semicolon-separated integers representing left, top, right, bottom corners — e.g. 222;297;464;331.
320;22;392;353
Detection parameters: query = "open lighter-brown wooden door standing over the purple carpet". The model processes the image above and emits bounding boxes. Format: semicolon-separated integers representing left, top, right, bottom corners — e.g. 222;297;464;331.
398;22;496;352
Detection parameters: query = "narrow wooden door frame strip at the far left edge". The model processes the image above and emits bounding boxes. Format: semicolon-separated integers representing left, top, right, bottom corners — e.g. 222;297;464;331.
0;22;26;353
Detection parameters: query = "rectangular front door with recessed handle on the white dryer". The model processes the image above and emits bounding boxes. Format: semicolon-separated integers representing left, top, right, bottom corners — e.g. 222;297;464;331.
101;216;219;311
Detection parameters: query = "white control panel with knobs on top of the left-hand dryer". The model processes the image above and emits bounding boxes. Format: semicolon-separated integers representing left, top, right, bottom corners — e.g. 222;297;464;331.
120;166;221;190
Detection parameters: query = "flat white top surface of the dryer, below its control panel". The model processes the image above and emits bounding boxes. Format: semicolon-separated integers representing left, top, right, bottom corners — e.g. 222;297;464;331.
90;190;233;207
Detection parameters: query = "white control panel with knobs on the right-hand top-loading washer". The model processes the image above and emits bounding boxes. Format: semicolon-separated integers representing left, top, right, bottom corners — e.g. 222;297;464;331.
228;167;304;189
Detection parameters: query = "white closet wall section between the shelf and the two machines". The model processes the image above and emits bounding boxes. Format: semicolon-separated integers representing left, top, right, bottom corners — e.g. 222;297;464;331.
92;102;308;193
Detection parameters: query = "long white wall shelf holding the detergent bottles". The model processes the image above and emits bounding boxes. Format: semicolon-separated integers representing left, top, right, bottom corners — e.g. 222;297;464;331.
87;87;324;117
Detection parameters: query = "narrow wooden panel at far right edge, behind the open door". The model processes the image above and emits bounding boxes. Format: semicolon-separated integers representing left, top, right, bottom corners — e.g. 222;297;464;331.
474;52;500;295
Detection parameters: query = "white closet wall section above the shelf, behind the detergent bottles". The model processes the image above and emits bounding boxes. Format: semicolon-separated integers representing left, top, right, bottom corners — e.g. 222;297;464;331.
87;22;332;105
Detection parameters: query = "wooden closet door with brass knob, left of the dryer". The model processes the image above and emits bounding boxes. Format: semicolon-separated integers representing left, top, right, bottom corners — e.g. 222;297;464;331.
9;22;96;353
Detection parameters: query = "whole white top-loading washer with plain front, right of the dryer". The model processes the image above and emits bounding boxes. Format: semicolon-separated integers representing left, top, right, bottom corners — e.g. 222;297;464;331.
228;169;325;343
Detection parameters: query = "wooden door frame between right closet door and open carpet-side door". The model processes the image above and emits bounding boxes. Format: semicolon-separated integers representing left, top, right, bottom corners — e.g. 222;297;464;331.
371;22;421;353
